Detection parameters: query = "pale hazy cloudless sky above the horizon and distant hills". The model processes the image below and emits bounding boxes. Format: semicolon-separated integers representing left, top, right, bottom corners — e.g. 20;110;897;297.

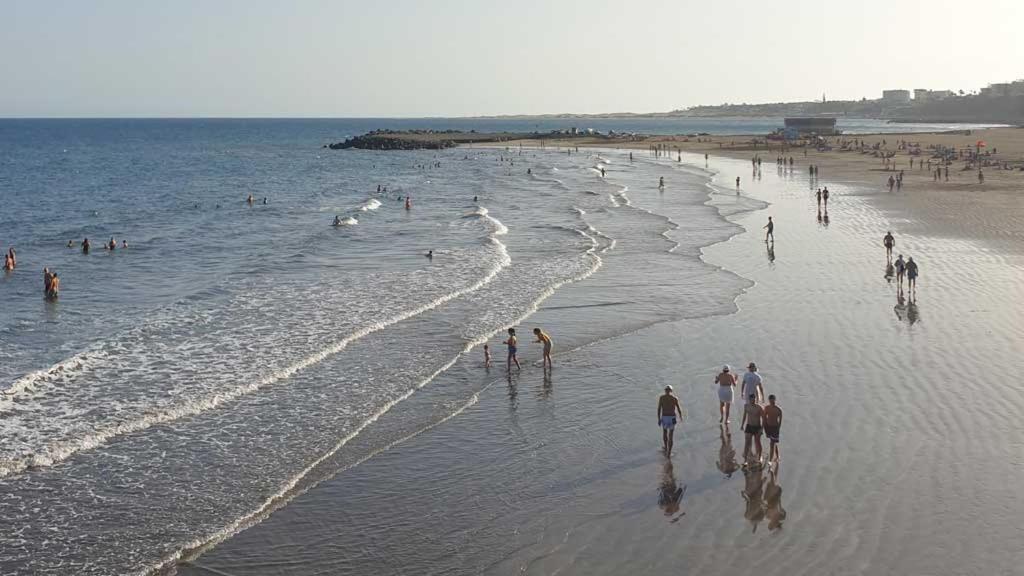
0;0;1024;117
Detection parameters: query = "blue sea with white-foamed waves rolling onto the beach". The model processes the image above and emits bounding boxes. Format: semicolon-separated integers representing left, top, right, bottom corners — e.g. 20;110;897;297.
0;119;991;574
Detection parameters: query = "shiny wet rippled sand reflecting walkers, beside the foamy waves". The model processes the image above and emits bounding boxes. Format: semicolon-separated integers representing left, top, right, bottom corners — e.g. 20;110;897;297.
177;146;1024;575
